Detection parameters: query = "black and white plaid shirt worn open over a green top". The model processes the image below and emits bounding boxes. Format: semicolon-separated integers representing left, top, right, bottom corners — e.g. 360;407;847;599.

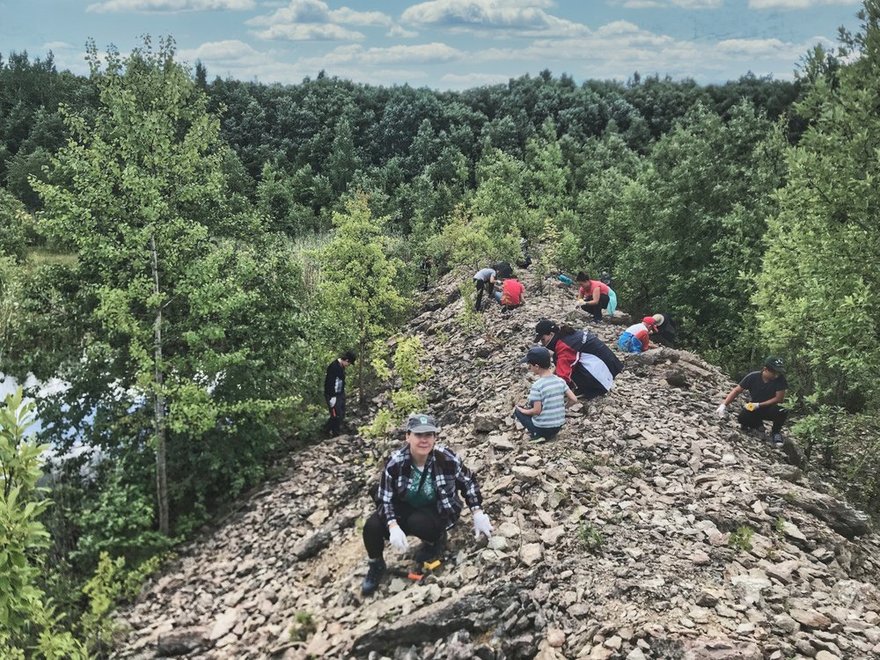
378;445;483;527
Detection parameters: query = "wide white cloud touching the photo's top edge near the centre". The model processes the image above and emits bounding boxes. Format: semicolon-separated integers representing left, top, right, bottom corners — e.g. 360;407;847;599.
401;0;587;36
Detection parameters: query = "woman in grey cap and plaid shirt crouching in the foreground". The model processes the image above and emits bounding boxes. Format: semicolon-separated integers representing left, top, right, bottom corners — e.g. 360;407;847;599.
361;414;492;595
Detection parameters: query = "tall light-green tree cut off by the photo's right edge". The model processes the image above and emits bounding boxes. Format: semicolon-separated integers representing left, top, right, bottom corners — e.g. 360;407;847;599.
755;0;880;506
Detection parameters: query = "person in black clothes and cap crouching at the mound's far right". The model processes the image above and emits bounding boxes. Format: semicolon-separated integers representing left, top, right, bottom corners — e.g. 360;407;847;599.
716;356;788;446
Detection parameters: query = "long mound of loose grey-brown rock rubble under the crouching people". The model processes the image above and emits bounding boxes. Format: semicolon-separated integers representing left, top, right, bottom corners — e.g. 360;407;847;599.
116;270;880;660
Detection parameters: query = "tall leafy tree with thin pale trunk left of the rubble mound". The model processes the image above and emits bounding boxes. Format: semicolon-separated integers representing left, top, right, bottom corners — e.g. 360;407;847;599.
36;40;298;534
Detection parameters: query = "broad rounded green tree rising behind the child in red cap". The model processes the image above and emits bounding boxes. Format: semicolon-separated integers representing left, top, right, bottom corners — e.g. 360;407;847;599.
615;103;785;367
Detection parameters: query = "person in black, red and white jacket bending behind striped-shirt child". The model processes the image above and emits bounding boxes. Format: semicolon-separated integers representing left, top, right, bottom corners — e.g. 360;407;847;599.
535;319;623;400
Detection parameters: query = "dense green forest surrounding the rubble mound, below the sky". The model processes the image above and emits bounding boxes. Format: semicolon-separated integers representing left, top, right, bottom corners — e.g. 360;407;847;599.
0;0;880;656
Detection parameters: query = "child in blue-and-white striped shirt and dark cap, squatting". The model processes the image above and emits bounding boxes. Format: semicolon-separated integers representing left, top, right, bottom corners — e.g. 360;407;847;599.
513;346;577;440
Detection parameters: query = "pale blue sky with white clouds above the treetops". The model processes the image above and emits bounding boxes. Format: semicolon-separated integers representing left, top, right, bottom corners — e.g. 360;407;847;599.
0;0;861;90
